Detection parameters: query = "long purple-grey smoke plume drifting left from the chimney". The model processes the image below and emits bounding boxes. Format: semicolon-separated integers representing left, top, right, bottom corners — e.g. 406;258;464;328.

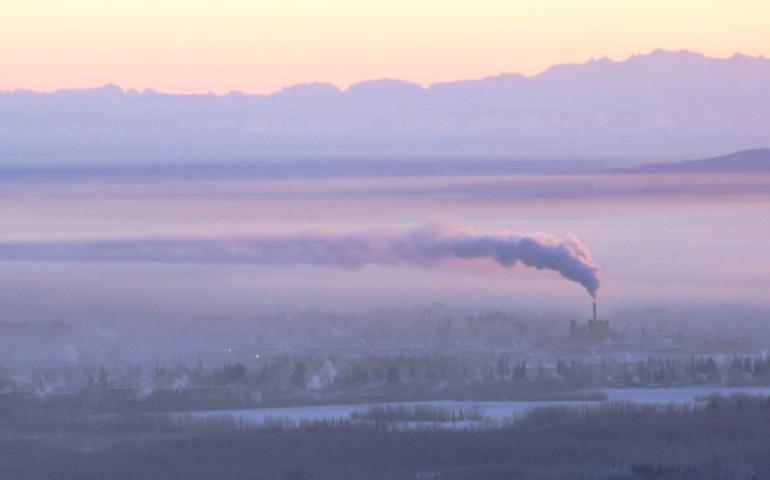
0;225;601;298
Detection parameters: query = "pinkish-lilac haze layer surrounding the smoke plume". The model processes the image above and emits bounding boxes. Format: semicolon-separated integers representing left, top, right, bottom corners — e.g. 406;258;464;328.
0;174;770;319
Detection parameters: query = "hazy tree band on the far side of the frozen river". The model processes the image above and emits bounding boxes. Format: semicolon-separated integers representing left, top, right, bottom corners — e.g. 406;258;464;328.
0;353;770;413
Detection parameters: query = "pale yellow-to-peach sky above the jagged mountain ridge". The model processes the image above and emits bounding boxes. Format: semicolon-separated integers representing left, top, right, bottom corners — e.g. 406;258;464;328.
0;0;770;93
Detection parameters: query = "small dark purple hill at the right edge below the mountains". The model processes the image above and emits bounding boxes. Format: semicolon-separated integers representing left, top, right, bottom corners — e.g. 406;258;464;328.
627;148;770;173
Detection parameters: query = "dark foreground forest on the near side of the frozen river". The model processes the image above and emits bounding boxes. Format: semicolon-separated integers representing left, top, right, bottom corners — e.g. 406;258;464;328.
0;395;770;480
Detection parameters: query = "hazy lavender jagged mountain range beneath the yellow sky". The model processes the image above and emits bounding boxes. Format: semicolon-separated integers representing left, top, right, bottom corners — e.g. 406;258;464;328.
0;50;770;166
